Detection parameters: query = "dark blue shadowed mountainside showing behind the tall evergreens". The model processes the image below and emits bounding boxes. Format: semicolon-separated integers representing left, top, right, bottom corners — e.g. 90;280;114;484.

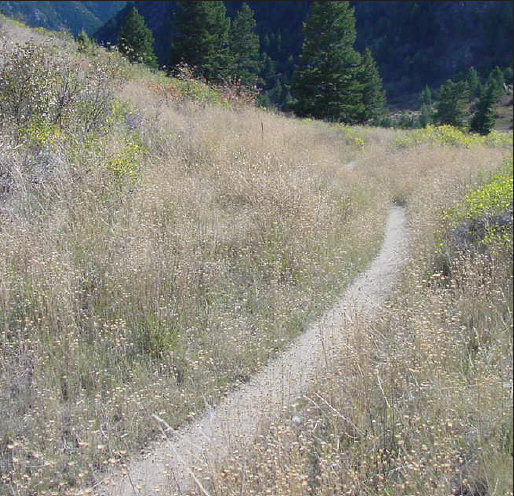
96;1;513;104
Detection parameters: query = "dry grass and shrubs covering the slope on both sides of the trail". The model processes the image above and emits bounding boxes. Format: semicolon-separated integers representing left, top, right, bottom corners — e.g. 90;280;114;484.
0;15;512;496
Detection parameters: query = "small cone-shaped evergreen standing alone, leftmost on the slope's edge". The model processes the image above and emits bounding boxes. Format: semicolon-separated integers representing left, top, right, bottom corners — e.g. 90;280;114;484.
118;7;157;67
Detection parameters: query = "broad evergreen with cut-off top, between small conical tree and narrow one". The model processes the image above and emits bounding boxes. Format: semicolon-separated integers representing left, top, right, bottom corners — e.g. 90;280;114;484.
170;1;233;82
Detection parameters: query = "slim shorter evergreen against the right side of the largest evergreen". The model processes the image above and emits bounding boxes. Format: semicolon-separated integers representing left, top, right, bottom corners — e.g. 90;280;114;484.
358;48;386;122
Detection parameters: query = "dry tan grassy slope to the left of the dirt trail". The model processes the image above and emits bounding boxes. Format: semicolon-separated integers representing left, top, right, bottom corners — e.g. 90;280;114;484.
0;16;506;496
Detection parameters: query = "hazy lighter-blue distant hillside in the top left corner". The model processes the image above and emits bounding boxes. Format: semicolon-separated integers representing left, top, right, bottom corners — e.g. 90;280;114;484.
0;0;127;36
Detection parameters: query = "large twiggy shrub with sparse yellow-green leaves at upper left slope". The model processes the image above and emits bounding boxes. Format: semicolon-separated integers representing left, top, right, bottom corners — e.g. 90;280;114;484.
0;42;119;144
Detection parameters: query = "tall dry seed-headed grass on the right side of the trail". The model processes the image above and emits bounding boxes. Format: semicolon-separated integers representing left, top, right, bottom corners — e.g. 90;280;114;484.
195;151;513;496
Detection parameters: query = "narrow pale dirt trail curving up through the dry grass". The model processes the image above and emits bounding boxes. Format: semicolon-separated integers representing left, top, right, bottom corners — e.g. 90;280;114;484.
97;206;409;496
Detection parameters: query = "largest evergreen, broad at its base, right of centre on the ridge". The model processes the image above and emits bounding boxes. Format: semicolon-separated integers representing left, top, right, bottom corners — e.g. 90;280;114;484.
293;2;364;123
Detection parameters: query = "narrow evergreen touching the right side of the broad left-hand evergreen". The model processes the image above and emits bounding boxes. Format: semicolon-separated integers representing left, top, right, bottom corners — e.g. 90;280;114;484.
230;3;261;86
